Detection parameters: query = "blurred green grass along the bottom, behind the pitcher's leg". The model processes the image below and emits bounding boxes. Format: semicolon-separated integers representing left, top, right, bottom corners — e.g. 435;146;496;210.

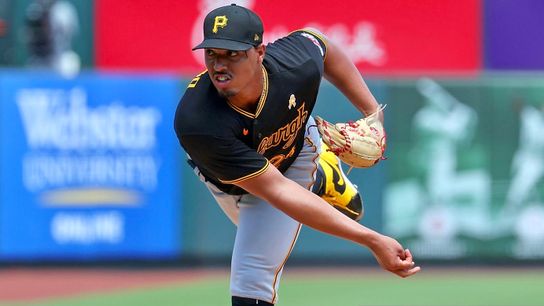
0;268;544;306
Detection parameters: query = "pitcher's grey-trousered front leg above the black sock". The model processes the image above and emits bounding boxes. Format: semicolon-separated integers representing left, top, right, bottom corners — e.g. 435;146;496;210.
230;195;301;304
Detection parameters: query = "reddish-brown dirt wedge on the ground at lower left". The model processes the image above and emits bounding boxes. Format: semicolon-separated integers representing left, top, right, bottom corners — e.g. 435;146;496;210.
0;268;224;302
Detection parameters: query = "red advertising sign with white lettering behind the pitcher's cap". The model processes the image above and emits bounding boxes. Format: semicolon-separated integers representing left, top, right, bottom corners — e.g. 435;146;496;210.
95;0;481;74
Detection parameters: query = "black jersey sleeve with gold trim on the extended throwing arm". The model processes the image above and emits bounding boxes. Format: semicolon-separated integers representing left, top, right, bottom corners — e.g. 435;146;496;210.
181;135;270;184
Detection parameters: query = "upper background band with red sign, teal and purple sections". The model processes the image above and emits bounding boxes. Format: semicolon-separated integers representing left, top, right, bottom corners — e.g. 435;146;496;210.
0;0;544;76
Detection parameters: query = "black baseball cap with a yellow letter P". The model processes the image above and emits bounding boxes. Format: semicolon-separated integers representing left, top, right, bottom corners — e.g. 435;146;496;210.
193;4;263;51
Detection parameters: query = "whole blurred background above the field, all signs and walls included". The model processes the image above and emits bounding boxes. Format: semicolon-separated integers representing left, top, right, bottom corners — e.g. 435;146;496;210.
0;0;544;304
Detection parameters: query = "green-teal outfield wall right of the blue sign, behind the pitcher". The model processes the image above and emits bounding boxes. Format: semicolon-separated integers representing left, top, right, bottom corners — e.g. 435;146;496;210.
184;76;544;261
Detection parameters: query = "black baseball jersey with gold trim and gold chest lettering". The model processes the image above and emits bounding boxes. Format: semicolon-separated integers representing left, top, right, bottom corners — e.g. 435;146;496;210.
174;31;326;194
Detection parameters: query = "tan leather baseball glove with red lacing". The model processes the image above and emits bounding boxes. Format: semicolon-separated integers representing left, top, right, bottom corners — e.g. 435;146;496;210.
315;105;386;168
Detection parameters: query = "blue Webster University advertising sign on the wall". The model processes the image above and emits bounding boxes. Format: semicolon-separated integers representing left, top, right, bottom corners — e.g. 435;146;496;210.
0;73;181;260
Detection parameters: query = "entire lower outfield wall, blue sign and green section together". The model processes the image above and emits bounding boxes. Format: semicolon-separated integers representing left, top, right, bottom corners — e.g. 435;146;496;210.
0;71;544;261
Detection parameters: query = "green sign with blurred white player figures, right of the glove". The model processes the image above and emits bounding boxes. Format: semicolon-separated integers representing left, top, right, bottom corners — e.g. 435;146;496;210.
384;78;544;260
